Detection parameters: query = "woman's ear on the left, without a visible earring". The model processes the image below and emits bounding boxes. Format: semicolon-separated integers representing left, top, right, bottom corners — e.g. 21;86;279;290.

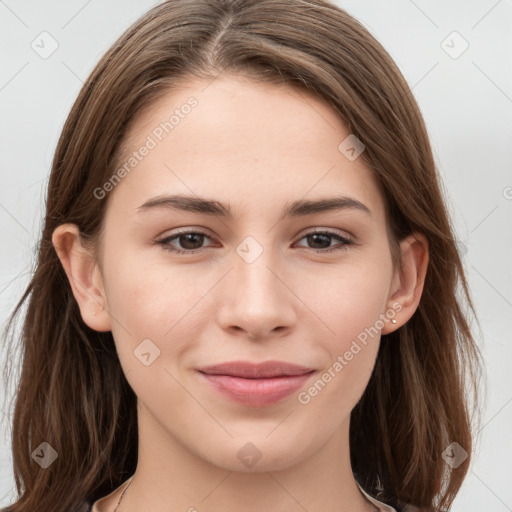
52;224;111;331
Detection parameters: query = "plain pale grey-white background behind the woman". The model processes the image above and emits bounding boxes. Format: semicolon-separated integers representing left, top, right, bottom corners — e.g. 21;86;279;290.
0;0;512;512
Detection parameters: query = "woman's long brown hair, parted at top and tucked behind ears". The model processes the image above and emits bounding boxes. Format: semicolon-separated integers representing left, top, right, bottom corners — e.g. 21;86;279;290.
0;0;481;512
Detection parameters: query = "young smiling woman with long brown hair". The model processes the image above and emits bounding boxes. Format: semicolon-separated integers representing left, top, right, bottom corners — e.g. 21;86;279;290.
1;0;480;512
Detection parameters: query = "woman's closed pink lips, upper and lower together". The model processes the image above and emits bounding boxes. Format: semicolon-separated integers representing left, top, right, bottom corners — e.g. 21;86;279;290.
198;361;315;407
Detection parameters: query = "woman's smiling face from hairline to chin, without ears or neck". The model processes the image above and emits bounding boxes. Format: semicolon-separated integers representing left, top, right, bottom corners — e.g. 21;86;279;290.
94;76;396;471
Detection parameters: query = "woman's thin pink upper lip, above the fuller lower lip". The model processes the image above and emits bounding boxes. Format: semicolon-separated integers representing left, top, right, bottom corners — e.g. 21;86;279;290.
199;361;314;379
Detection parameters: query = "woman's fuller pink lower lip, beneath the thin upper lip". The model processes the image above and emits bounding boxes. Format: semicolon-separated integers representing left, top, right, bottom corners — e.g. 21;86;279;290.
199;372;314;407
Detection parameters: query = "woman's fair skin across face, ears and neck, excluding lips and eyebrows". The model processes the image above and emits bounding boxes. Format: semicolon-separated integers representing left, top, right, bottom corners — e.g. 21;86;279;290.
53;75;428;512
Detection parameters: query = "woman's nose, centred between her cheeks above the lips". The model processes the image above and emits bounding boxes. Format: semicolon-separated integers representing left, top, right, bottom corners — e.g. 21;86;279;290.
217;244;300;339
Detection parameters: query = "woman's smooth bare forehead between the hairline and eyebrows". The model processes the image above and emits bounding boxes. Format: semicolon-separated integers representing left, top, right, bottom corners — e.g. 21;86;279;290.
109;75;383;224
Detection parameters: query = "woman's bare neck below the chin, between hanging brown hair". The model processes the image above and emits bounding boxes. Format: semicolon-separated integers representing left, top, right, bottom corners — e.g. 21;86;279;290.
116;408;376;512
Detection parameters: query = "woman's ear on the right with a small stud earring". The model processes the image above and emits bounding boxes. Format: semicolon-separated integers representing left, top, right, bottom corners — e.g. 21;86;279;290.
381;233;429;334
